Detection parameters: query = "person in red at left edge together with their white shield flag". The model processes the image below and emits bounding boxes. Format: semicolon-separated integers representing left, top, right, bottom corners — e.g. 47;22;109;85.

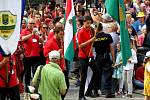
0;0;25;100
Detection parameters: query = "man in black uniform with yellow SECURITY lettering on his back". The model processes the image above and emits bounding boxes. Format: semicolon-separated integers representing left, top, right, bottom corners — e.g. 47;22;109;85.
93;23;115;98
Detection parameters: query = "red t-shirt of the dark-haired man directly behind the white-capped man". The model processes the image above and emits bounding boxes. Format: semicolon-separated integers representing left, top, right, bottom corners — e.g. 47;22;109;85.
44;36;65;71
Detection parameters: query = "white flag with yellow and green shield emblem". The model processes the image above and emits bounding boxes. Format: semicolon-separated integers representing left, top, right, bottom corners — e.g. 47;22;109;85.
0;0;25;55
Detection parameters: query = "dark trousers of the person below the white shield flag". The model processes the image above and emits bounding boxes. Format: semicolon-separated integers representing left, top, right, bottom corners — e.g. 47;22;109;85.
0;85;20;100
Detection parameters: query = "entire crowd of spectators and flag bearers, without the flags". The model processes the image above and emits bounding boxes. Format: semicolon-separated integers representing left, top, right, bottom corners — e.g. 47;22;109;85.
0;0;150;100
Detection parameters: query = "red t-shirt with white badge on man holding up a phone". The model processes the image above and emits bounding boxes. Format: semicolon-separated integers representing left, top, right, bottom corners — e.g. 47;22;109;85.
21;29;40;57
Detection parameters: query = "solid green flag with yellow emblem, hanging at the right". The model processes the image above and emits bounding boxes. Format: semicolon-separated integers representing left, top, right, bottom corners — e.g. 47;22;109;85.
105;0;132;65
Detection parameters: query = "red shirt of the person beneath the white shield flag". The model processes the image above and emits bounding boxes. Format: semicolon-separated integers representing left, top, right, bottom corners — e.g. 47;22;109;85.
0;54;19;87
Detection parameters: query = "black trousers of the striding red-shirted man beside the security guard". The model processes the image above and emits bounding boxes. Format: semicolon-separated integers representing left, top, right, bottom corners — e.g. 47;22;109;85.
79;58;99;97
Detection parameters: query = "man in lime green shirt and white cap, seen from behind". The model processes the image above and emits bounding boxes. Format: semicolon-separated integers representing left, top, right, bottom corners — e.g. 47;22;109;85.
32;50;67;100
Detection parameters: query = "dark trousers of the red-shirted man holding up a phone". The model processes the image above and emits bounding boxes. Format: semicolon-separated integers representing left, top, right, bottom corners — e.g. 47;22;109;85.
24;57;40;92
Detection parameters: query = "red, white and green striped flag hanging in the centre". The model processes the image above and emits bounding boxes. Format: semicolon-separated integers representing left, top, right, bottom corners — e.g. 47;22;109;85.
64;0;77;62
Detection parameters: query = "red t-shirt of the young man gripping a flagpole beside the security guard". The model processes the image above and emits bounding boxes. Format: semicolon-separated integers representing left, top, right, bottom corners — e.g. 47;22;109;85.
77;27;93;58
